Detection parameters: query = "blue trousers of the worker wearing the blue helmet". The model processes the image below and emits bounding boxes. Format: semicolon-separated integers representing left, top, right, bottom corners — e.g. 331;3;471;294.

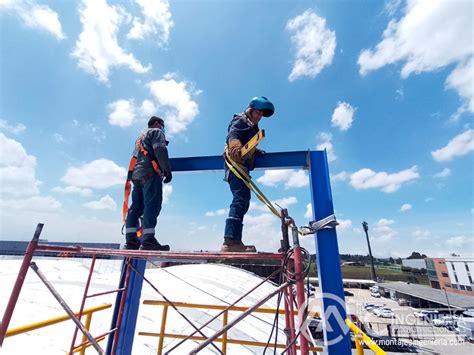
224;172;250;241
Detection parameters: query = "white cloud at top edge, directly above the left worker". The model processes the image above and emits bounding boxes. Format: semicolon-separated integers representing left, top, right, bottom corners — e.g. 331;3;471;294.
127;0;173;45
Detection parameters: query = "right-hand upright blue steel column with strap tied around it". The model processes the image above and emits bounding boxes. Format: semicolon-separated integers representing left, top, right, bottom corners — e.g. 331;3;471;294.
309;151;351;355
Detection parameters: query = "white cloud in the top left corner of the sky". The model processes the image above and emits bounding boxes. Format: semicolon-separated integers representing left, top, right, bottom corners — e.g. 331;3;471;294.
0;0;66;40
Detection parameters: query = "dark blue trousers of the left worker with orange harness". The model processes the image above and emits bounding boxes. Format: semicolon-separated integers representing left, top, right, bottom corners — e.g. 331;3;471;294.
125;174;163;243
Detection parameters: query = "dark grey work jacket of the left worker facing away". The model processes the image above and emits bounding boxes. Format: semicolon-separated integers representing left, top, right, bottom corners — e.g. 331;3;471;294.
132;128;171;181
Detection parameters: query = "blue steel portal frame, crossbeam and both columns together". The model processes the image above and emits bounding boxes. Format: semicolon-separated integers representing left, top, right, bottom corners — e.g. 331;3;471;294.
118;151;351;355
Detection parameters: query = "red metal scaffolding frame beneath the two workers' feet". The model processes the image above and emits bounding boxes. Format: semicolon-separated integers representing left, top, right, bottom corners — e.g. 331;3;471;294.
0;224;309;355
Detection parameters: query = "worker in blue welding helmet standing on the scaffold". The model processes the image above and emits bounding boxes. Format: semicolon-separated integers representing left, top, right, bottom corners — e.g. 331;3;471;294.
221;96;275;252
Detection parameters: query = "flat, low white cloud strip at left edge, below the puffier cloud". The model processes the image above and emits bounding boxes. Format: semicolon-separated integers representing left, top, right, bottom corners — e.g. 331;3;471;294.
0;196;62;213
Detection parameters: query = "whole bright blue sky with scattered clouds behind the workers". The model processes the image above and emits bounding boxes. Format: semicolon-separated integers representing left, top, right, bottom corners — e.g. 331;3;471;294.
0;0;474;257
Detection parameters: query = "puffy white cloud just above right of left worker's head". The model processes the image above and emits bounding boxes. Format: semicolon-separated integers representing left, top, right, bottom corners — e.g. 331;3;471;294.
147;74;200;134
